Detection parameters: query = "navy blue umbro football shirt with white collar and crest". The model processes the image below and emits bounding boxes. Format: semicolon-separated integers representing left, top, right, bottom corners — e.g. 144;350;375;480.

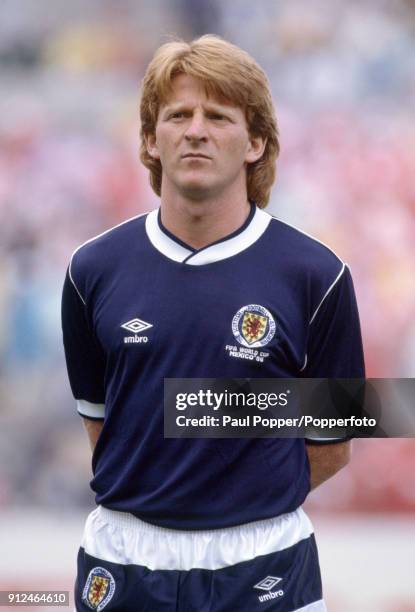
62;205;364;529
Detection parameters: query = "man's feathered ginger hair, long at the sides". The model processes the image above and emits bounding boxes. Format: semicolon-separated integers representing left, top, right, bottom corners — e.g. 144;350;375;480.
140;34;280;208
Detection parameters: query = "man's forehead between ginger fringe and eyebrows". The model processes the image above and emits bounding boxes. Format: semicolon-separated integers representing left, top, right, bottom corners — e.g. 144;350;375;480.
160;74;242;111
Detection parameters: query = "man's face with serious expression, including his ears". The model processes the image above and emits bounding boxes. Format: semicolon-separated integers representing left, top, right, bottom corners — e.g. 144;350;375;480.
146;74;265;200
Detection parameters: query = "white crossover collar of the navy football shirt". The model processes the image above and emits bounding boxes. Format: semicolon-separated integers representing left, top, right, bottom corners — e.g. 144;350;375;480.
146;207;272;266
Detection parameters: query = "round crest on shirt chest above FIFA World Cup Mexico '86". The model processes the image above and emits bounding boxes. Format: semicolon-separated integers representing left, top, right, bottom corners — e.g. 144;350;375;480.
232;304;275;347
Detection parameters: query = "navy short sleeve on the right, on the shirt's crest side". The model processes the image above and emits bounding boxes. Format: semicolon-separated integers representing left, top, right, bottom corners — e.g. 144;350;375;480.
301;266;365;443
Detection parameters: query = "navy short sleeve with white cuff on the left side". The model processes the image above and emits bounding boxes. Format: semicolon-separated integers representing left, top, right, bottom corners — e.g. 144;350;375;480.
62;269;105;419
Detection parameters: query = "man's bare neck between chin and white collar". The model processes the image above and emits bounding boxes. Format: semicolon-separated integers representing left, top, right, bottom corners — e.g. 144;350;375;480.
161;183;251;249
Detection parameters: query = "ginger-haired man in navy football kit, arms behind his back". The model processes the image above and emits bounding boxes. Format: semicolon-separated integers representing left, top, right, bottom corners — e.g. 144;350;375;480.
62;36;364;612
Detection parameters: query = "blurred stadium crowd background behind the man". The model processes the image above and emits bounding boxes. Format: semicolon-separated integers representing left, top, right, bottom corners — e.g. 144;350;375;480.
0;0;415;612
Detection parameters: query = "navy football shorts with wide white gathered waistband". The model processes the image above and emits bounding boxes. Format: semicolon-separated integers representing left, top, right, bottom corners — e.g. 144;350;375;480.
75;506;326;612
